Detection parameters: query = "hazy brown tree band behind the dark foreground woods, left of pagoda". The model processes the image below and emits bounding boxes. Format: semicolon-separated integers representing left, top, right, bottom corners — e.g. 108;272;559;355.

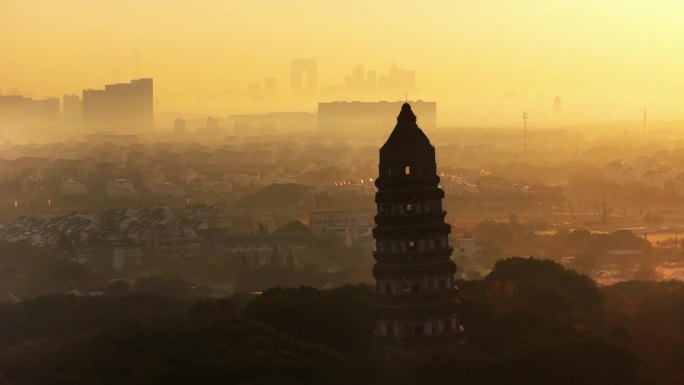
0;237;370;302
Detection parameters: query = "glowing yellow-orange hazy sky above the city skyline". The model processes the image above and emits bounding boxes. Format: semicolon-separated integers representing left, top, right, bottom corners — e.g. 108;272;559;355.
0;0;684;122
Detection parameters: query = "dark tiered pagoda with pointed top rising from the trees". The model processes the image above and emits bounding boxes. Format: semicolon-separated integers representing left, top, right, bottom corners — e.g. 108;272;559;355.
373;103;461;341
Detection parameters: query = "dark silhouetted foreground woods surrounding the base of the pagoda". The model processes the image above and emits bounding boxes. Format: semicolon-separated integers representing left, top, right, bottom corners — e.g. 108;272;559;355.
0;258;684;385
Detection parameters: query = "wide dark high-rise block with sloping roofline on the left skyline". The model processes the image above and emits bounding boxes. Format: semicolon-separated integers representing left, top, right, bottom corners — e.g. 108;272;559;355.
83;78;154;131
